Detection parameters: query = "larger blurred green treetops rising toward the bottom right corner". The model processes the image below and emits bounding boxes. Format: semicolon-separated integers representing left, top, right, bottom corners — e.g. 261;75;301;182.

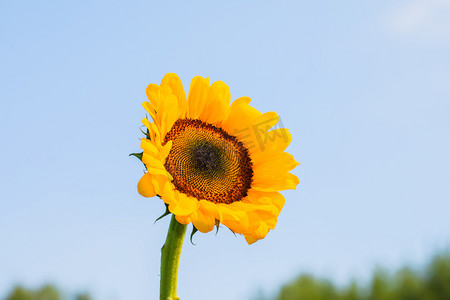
256;252;450;300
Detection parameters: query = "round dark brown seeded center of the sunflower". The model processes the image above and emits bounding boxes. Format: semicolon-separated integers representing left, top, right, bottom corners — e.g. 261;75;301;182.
164;119;253;204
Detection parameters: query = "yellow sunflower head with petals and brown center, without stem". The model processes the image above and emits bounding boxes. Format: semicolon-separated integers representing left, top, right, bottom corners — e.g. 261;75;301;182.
138;73;299;244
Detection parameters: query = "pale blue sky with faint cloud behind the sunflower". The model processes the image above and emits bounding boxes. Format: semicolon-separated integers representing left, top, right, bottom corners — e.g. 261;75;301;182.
0;0;450;300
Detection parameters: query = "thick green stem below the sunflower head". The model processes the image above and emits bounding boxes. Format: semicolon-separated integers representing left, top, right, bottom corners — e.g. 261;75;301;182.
159;215;187;300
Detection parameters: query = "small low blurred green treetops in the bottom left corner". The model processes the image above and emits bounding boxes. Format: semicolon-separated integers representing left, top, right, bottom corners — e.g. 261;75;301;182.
2;284;91;300
